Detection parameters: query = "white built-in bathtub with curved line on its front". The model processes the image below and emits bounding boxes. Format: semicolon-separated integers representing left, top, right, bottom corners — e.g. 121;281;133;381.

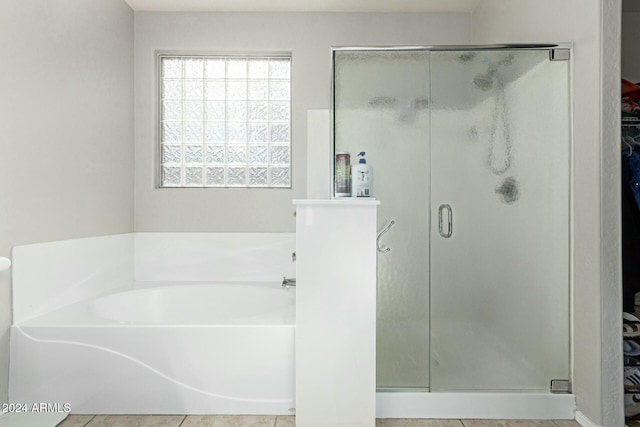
11;282;295;414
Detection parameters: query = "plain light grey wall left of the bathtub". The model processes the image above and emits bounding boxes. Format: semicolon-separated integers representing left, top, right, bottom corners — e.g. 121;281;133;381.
0;0;133;412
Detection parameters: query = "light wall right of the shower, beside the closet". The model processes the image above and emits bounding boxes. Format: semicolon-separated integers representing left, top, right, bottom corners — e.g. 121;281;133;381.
473;0;623;426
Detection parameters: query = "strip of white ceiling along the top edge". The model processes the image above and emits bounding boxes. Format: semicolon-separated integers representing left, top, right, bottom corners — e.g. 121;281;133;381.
125;0;480;12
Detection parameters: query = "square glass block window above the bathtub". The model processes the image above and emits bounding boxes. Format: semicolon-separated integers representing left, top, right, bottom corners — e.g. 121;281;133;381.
160;56;291;188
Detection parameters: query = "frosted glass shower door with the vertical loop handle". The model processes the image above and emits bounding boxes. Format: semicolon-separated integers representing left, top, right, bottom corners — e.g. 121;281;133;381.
430;50;570;390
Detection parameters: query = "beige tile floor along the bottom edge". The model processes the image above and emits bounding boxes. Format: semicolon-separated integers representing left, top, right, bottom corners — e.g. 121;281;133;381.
58;415;580;427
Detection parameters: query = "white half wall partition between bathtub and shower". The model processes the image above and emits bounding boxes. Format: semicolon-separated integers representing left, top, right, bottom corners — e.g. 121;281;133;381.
294;199;380;427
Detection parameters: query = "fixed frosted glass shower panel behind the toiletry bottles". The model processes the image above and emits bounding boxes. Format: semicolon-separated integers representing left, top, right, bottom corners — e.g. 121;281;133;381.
334;50;430;389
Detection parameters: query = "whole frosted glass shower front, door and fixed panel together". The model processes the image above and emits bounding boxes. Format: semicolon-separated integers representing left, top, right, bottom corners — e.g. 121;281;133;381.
333;45;570;391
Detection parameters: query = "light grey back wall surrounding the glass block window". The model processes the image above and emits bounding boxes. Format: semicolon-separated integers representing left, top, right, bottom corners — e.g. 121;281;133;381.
135;12;470;232
